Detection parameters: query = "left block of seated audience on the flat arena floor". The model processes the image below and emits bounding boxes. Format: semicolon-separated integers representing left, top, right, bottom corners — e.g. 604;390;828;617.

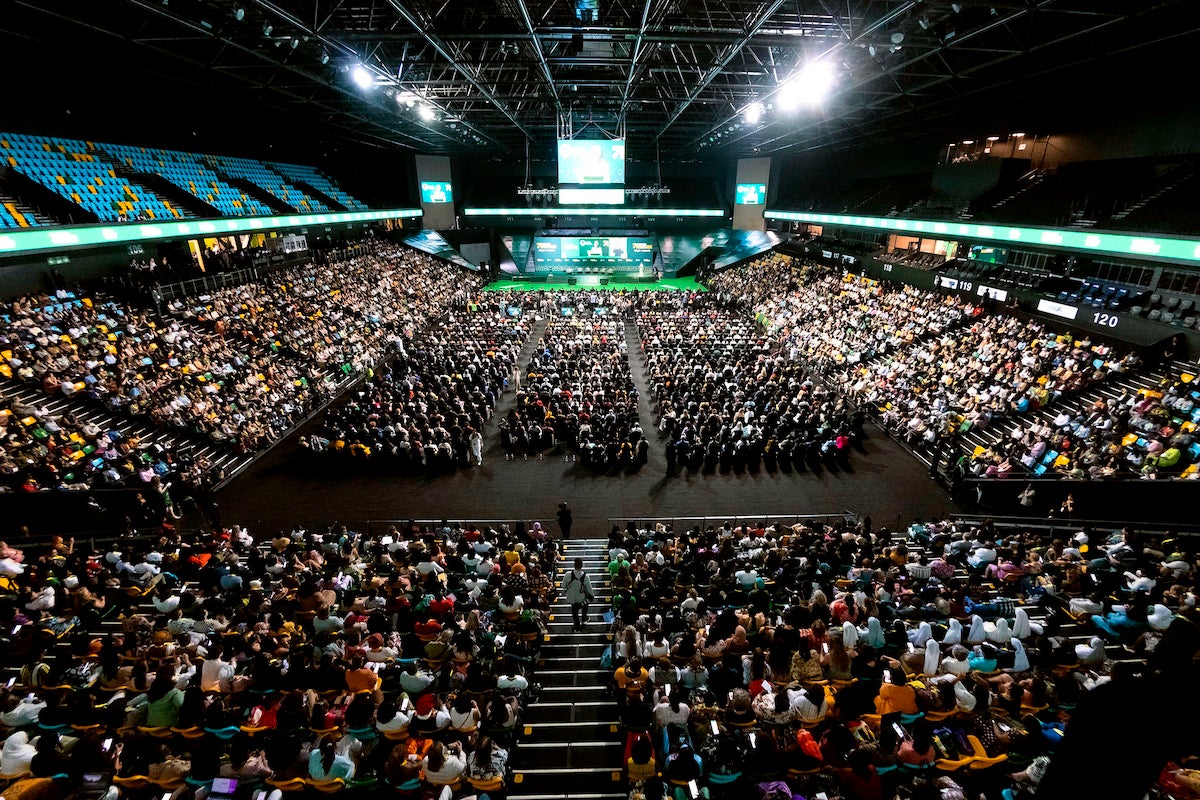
300;292;529;473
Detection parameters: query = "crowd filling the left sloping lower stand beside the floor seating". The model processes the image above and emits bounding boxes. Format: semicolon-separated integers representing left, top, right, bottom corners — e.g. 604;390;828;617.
0;242;478;492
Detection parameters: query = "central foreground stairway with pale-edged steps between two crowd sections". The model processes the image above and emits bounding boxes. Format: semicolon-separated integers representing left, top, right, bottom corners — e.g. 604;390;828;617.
509;539;625;800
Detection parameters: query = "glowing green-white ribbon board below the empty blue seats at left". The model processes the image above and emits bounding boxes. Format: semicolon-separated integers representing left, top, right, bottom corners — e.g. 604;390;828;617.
0;209;421;257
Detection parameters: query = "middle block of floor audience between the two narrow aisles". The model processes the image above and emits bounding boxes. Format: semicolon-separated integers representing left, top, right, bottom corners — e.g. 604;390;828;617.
502;291;648;470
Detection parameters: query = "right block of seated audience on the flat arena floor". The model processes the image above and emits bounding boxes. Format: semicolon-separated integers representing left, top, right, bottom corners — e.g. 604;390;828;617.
637;293;862;473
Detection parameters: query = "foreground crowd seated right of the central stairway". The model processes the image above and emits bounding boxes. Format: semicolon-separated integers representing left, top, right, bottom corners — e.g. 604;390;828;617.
601;522;1200;800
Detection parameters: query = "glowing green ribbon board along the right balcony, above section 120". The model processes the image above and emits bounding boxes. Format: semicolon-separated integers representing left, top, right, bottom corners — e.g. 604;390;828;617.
763;210;1200;264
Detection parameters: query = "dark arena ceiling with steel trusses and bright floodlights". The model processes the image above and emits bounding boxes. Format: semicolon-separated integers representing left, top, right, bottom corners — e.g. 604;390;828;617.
0;0;1200;158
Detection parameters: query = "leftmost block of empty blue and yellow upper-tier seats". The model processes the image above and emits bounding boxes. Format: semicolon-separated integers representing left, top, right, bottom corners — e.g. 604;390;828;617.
0;133;186;225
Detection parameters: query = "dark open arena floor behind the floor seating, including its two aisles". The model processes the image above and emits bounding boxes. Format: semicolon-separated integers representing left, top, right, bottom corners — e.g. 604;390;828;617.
218;311;956;537
